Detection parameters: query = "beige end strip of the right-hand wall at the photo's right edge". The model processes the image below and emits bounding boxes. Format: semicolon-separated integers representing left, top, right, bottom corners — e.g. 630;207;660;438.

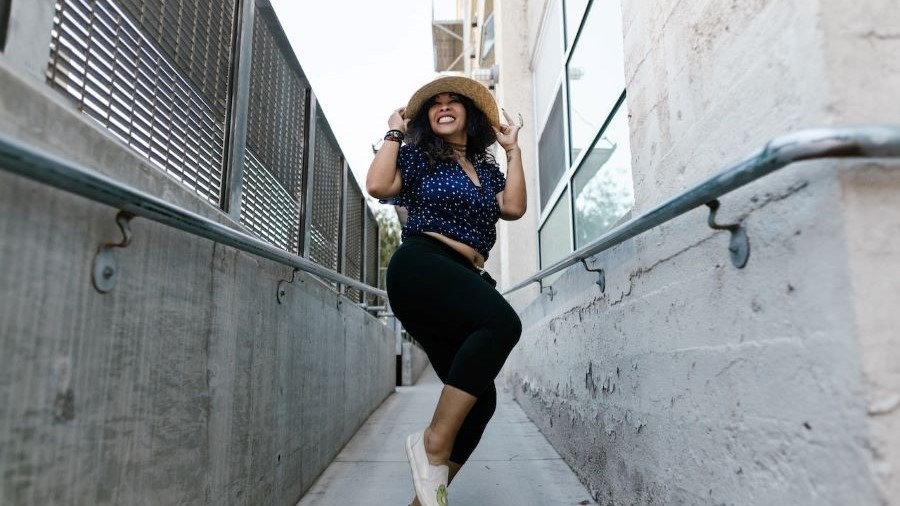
820;0;900;504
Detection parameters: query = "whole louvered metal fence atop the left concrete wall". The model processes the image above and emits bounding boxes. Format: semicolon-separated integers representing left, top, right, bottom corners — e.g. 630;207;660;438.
44;0;379;298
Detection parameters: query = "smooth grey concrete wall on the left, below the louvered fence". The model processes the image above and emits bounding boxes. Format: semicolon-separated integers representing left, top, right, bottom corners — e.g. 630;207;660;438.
0;34;396;505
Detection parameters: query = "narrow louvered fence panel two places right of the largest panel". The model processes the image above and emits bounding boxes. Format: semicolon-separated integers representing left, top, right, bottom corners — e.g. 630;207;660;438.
308;112;344;270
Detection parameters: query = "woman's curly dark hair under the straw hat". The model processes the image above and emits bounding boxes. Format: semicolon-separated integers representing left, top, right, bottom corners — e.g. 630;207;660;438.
406;93;497;167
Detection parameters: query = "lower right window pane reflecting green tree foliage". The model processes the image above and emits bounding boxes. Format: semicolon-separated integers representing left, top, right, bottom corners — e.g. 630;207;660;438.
572;102;634;248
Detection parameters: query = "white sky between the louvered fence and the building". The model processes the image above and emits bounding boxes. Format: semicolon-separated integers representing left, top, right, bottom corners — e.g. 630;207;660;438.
271;0;446;191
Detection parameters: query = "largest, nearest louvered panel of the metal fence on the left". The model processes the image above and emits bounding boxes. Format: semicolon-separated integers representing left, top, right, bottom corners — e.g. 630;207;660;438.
47;0;228;204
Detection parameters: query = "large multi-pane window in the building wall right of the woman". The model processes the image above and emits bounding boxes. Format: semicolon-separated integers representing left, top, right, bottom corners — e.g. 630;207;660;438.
534;0;634;268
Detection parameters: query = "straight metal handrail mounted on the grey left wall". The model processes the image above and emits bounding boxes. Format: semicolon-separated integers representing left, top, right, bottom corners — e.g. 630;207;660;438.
0;135;387;298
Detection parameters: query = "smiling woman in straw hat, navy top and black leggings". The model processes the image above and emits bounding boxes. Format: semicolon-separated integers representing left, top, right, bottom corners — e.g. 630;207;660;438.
366;76;526;506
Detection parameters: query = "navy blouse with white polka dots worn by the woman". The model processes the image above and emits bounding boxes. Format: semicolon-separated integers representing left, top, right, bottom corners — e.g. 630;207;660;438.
383;144;506;259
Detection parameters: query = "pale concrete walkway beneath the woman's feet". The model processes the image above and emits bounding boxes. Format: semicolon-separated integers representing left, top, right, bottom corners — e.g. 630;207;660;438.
298;367;596;506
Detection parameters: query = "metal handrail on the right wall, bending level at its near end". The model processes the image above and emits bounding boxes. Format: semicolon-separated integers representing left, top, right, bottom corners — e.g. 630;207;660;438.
503;125;900;295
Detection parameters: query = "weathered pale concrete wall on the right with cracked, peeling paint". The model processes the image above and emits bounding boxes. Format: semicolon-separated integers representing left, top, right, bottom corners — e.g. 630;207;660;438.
501;0;900;505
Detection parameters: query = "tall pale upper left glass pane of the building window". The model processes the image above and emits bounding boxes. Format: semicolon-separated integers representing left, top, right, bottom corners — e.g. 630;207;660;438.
534;2;564;125
